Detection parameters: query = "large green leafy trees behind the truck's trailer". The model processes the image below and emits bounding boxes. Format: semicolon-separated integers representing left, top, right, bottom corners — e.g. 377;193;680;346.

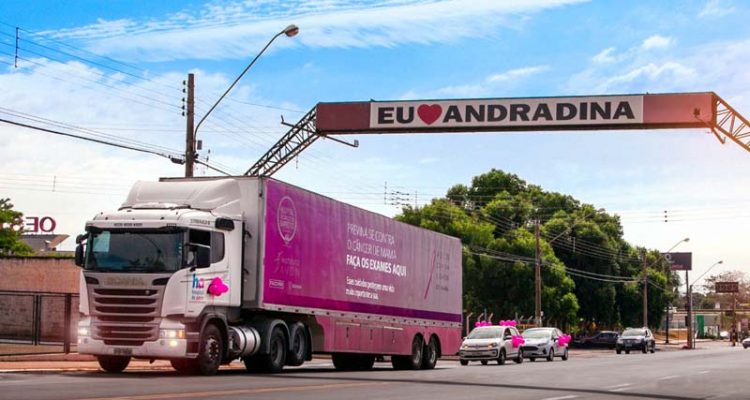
396;169;677;329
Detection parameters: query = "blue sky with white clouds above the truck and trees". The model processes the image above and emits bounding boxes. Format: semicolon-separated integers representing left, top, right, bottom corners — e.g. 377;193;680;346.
0;0;750;290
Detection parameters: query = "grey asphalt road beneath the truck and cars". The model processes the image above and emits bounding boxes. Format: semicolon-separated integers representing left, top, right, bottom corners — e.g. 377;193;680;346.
0;347;750;400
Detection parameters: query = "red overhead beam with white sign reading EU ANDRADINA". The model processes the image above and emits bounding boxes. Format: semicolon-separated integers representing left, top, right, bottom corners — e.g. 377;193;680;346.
317;93;715;134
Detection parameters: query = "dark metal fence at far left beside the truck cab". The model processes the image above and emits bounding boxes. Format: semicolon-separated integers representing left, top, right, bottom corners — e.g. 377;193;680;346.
0;291;78;356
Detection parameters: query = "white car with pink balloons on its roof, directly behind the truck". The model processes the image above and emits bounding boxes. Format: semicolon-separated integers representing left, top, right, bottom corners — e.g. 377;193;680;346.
458;325;523;365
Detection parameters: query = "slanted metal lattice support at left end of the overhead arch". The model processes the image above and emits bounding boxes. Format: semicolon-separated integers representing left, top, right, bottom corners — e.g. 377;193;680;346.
245;107;320;176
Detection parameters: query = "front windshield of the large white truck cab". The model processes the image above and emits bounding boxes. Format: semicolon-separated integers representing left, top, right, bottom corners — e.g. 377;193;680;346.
86;230;185;272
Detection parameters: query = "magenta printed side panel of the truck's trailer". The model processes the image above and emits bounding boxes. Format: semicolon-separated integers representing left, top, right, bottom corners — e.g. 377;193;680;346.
263;180;462;322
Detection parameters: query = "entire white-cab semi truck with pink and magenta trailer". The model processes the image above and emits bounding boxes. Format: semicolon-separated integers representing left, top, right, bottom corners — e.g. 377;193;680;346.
76;177;461;375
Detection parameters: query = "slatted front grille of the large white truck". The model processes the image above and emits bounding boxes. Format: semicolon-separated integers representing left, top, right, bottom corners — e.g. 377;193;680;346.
88;275;165;346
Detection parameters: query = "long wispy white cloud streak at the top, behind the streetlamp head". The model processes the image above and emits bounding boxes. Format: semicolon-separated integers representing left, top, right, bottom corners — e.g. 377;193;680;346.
44;0;586;61
